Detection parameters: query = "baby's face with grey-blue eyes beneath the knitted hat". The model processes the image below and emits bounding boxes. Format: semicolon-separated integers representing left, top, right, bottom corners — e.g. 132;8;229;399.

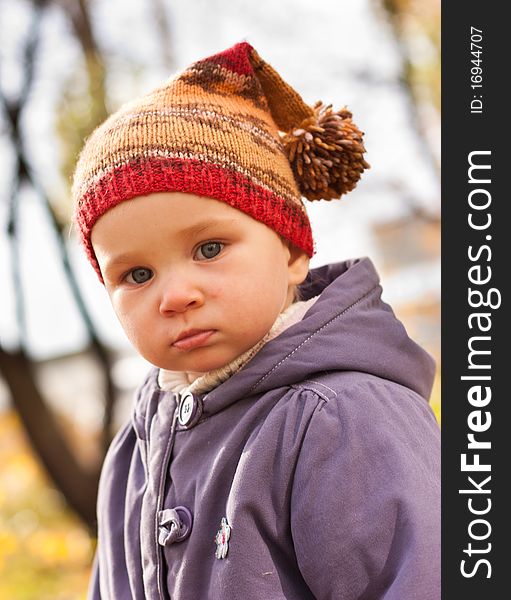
91;192;309;373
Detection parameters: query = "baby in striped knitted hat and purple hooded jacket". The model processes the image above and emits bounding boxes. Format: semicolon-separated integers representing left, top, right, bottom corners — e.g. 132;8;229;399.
73;42;440;600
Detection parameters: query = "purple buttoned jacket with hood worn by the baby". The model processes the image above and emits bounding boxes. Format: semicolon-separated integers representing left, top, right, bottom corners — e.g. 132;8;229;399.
89;259;440;600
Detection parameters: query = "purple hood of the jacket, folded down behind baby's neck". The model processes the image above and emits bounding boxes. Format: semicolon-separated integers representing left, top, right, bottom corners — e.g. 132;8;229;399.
137;258;435;422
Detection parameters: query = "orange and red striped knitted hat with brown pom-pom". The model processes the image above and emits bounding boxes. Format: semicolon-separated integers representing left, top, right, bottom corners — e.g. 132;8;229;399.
72;42;369;279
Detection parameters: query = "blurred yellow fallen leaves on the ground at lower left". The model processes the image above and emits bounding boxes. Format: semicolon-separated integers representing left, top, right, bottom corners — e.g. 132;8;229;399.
0;412;94;600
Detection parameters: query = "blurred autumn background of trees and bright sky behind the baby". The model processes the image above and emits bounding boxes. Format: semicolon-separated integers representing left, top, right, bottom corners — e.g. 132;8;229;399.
0;0;440;600
